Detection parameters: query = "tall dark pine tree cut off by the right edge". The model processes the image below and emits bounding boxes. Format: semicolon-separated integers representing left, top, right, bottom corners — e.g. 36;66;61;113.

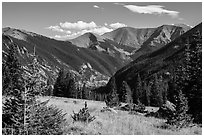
185;30;202;123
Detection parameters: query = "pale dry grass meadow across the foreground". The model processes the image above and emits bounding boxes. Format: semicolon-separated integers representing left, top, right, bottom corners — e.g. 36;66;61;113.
37;97;202;135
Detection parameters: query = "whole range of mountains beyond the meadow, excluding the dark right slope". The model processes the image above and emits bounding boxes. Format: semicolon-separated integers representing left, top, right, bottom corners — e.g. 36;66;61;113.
2;25;190;86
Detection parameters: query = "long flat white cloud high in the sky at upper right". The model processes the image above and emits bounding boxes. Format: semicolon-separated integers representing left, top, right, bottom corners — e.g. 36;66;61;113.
123;5;179;18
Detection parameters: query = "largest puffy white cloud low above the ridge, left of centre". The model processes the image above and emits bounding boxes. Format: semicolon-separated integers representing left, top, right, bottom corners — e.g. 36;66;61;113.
60;21;97;30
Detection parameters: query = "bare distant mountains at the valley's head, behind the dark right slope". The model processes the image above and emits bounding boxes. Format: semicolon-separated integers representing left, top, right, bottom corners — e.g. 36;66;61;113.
103;24;190;59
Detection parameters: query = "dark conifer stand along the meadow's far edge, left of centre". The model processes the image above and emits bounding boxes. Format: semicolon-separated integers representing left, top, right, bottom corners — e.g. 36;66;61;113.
52;68;106;101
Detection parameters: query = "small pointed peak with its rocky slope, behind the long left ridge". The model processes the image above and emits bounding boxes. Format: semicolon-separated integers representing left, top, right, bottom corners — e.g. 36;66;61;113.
69;32;134;62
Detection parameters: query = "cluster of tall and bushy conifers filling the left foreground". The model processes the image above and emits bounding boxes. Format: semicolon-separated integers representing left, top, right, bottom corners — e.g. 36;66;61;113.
2;45;66;135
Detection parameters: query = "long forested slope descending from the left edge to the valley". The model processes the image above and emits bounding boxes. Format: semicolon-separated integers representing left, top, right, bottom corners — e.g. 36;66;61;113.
2;28;129;86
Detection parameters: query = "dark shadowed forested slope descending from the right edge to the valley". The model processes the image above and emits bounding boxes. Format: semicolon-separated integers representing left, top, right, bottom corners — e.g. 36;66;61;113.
104;24;202;105
